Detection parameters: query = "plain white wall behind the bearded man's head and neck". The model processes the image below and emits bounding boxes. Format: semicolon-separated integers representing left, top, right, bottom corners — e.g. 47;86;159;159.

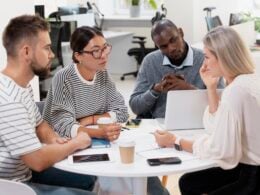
0;0;39;100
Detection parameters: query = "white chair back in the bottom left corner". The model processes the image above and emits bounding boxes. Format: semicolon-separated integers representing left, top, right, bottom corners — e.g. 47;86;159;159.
0;179;37;195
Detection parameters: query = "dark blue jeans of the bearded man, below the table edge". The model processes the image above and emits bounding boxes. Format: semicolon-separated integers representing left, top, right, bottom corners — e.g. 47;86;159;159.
27;167;96;194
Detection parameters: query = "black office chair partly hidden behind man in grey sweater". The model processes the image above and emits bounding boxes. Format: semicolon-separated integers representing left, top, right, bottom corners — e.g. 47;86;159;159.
120;4;167;81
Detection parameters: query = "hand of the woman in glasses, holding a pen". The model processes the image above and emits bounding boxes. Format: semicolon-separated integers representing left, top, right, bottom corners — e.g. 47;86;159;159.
100;123;121;141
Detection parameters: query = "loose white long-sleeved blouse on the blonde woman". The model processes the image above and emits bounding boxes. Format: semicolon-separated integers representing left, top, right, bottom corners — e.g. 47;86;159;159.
193;74;260;169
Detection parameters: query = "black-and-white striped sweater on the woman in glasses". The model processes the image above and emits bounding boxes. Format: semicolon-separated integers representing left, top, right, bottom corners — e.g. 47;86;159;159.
43;64;128;137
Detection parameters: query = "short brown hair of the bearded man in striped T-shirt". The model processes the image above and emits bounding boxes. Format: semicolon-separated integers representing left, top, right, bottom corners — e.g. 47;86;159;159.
2;15;49;56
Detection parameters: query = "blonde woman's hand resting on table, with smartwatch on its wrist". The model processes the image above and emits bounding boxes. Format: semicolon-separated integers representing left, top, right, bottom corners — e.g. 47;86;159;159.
154;130;176;147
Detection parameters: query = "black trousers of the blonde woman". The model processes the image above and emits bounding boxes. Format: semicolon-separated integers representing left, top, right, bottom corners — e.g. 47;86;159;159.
179;163;260;195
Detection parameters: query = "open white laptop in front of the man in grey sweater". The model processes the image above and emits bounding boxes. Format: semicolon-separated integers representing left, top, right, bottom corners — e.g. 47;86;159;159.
165;90;219;130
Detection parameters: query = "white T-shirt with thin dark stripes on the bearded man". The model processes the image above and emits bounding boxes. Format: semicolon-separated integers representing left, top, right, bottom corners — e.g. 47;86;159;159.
0;73;42;181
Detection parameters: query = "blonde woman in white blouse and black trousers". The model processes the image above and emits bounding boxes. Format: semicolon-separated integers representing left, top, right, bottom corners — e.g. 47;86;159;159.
155;27;260;195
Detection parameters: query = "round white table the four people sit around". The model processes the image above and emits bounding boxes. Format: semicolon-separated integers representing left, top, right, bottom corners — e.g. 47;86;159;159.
55;119;215;195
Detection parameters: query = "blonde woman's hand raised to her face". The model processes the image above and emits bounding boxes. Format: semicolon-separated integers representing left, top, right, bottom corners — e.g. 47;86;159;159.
200;64;219;89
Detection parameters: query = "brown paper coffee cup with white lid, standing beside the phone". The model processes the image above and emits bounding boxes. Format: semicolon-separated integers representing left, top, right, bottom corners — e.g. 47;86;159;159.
118;141;135;164
